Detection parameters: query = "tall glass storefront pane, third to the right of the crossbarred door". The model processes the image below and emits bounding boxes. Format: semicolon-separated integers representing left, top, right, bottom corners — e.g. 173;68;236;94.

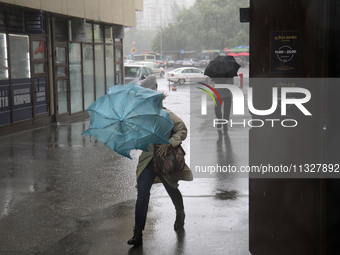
94;45;105;99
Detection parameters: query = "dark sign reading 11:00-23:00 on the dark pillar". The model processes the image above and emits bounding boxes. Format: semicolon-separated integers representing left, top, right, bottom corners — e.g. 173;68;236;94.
270;31;301;73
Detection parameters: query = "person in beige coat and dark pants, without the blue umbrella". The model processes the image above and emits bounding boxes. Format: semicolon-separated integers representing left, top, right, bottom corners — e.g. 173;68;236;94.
128;102;193;246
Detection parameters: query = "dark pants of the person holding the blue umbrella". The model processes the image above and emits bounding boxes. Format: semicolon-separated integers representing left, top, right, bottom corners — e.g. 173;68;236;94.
135;161;184;229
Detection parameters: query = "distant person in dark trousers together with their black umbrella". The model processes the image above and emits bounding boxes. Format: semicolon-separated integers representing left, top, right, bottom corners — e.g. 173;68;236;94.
204;56;241;130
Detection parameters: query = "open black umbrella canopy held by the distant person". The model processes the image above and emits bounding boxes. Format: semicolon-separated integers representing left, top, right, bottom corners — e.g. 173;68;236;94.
204;56;241;78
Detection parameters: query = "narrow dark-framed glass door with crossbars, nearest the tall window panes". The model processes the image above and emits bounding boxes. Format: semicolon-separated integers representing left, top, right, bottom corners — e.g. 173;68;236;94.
54;43;70;114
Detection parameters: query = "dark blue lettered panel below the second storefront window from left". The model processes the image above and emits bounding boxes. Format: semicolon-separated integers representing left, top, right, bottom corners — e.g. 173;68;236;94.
12;78;33;122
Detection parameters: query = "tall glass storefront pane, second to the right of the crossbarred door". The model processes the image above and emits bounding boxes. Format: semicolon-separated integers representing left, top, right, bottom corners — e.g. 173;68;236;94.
83;44;94;109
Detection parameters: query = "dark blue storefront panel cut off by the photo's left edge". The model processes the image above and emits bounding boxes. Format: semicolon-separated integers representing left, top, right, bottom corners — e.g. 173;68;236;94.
0;80;12;125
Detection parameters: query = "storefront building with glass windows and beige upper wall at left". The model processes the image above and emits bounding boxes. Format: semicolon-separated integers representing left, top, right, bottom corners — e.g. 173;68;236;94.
0;0;143;135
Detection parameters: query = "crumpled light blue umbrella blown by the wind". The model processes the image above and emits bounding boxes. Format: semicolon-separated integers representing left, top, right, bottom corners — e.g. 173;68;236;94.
82;84;174;158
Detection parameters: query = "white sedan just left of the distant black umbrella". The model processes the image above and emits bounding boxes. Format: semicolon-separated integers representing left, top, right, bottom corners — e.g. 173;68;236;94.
168;67;209;85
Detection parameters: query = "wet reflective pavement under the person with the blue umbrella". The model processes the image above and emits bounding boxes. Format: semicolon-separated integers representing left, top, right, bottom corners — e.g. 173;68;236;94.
0;76;250;255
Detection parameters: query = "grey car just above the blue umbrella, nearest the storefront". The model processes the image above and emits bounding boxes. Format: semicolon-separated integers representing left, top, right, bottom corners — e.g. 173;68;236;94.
124;65;158;90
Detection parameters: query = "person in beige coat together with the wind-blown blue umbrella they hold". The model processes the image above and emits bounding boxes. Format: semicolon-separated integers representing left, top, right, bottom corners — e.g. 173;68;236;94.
83;84;193;246
